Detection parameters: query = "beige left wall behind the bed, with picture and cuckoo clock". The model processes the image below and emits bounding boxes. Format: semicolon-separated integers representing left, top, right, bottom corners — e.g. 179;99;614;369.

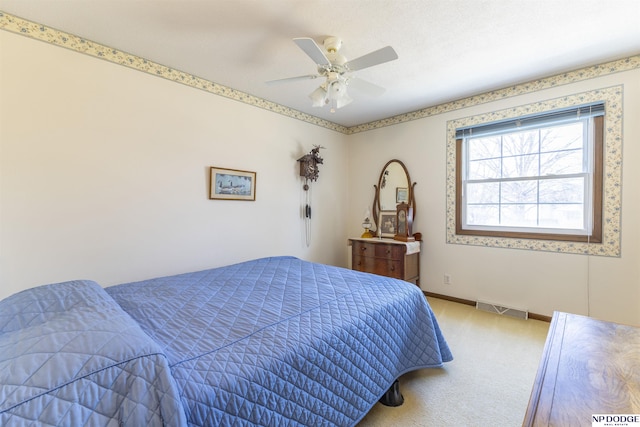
0;31;347;297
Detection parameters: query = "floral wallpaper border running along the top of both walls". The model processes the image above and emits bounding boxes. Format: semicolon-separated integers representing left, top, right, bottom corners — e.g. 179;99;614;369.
0;11;640;135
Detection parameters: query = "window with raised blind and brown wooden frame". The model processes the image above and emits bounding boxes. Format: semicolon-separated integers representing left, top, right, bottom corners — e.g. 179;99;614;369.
456;103;604;243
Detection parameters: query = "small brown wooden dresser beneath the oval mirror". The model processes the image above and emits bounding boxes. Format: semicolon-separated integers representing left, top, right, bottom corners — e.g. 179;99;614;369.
349;238;420;286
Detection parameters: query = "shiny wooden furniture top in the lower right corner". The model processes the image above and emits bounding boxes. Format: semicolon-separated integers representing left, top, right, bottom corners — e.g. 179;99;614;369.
522;312;640;427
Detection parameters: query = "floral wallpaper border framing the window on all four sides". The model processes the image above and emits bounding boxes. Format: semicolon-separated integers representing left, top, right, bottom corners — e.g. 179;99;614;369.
446;86;623;257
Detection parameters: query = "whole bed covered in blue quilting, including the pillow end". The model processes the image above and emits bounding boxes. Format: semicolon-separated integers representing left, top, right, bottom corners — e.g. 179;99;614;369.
0;257;452;426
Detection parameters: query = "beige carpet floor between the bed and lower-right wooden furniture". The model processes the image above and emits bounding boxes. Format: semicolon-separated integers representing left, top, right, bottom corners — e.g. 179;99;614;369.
358;298;549;427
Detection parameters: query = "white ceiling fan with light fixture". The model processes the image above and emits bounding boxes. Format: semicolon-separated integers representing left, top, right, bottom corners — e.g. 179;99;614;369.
267;36;398;113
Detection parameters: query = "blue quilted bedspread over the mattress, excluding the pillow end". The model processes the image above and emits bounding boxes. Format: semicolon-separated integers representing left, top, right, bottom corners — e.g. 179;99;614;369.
106;257;452;426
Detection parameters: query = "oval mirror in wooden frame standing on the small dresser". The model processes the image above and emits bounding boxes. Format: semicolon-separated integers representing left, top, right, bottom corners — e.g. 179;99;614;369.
373;159;416;230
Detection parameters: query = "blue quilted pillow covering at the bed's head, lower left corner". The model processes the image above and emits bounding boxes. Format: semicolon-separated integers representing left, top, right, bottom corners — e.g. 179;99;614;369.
0;281;186;426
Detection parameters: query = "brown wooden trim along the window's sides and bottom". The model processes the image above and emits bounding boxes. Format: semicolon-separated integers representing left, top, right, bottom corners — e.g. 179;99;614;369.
455;115;604;243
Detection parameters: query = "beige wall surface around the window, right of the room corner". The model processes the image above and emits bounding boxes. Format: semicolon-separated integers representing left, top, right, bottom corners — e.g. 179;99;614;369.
348;70;640;325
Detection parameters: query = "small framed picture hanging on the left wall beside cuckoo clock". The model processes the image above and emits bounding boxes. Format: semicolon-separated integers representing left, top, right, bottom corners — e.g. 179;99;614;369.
209;167;256;201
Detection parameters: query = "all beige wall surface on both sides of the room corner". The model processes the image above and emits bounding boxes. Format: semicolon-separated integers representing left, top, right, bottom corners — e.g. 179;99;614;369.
0;31;640;324
